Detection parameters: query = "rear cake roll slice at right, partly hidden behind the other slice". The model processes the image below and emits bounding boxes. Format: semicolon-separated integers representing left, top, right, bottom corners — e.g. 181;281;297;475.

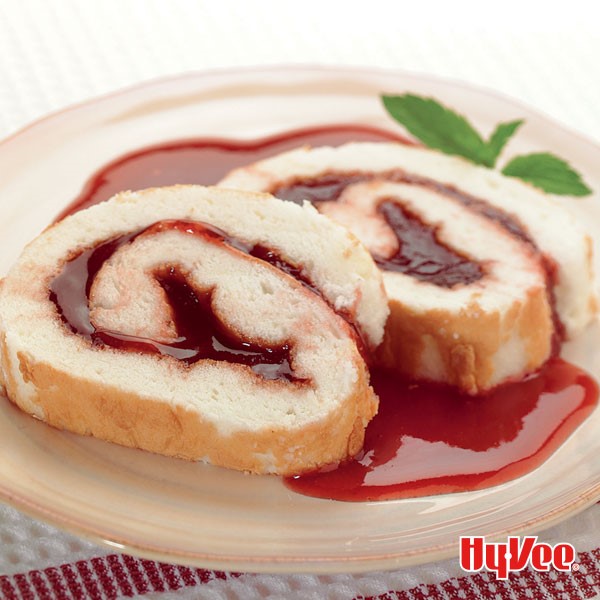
220;143;596;394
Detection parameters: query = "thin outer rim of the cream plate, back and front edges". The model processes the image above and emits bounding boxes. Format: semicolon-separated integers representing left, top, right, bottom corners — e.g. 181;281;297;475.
0;64;600;574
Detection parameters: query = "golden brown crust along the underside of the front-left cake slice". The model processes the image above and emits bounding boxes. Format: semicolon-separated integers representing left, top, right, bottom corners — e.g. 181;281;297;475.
0;338;377;475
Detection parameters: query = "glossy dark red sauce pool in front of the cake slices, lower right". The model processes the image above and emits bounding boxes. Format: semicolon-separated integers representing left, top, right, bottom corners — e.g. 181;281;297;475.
286;358;598;501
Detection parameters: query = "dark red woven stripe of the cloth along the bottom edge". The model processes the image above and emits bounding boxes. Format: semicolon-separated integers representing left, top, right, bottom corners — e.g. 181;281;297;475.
0;548;600;600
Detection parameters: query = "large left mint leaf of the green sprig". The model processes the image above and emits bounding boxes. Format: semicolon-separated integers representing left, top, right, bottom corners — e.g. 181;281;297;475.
381;94;488;164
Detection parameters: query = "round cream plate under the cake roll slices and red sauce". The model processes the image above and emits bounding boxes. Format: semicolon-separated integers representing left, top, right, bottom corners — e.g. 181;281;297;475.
0;68;600;573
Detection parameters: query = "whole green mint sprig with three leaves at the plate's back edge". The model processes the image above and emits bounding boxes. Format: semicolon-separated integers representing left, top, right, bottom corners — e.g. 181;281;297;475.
381;94;592;196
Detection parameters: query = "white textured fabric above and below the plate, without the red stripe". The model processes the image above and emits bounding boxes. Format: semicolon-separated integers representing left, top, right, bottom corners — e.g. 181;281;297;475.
0;0;600;599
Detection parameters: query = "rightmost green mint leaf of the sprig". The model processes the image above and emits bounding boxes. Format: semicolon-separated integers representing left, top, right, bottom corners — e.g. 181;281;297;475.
502;152;592;196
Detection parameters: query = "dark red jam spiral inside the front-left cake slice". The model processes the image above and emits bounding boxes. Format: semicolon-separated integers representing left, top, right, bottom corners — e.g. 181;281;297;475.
50;221;361;383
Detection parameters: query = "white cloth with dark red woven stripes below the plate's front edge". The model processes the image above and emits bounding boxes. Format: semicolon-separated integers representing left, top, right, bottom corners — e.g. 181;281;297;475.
0;503;600;600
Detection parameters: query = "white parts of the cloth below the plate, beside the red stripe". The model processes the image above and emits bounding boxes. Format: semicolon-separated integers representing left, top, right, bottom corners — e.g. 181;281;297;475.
0;504;600;600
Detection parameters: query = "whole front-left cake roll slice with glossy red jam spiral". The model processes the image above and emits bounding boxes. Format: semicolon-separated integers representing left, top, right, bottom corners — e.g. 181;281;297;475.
0;186;388;474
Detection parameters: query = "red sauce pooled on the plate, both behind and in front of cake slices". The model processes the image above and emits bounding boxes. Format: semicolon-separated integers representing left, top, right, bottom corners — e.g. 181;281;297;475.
59;125;598;501
